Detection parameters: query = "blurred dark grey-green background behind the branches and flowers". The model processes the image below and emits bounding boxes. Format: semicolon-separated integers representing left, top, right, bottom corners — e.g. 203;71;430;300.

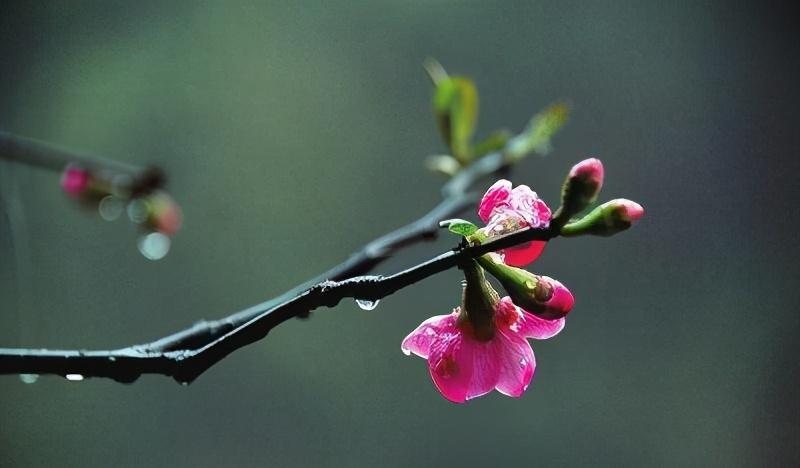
0;1;800;467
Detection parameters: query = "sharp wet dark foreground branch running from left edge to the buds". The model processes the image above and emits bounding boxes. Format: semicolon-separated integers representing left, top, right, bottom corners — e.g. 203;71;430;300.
0;228;554;383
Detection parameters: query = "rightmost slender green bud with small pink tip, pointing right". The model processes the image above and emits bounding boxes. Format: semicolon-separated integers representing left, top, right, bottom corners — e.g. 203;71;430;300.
561;198;644;237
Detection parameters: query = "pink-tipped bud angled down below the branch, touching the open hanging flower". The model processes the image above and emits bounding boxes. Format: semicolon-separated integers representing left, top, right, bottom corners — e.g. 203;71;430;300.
478;255;575;320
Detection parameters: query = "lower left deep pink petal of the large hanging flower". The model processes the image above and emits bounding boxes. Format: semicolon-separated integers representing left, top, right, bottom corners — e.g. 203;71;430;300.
428;333;474;403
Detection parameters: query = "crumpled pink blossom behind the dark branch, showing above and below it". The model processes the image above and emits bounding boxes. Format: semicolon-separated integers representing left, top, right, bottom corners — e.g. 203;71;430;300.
478;179;551;266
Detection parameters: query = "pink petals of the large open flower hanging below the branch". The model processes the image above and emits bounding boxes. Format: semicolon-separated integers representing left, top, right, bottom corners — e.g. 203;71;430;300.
401;297;564;403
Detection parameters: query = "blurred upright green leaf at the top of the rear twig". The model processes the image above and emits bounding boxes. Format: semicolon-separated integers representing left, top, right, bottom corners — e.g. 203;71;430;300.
433;76;478;164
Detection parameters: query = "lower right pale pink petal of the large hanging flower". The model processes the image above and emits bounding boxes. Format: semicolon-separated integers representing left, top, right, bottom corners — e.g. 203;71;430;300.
493;330;536;397
